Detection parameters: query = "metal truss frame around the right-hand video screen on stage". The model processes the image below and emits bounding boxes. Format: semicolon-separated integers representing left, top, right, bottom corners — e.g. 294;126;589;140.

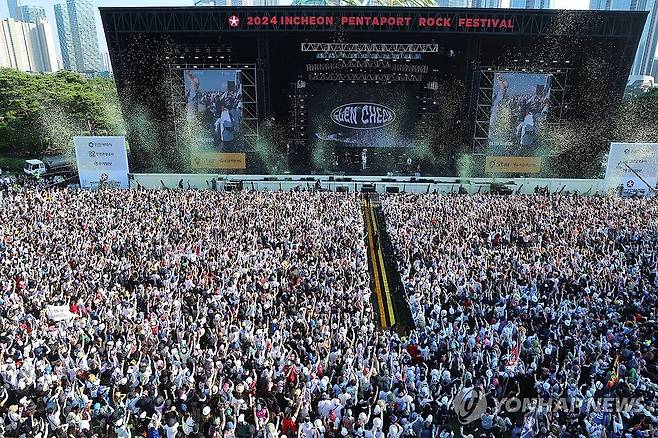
473;66;571;154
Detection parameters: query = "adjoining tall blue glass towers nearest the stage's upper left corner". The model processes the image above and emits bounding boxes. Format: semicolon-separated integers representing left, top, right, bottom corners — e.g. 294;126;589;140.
55;0;102;72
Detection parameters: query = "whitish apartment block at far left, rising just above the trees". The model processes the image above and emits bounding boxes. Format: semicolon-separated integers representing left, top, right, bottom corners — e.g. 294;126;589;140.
0;18;58;72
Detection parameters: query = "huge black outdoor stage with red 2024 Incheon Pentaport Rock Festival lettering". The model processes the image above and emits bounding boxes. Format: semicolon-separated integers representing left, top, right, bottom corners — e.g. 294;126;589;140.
100;7;646;178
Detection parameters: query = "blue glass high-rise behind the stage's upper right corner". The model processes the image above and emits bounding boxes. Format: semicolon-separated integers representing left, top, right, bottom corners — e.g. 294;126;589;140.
590;0;658;76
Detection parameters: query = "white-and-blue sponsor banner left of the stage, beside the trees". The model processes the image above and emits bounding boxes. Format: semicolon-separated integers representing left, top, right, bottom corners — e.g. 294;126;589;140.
73;137;128;189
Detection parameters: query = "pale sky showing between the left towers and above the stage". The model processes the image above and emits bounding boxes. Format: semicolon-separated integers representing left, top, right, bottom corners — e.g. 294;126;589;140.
0;0;616;61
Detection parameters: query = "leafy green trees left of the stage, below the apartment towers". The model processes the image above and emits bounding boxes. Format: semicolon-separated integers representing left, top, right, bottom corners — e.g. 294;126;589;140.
0;69;125;161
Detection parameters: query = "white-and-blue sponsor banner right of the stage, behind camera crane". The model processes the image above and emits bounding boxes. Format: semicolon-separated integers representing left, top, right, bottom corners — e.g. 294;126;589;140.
605;143;658;196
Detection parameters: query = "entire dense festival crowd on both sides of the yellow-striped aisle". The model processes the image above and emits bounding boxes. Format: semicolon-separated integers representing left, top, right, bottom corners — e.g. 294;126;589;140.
0;186;658;438
